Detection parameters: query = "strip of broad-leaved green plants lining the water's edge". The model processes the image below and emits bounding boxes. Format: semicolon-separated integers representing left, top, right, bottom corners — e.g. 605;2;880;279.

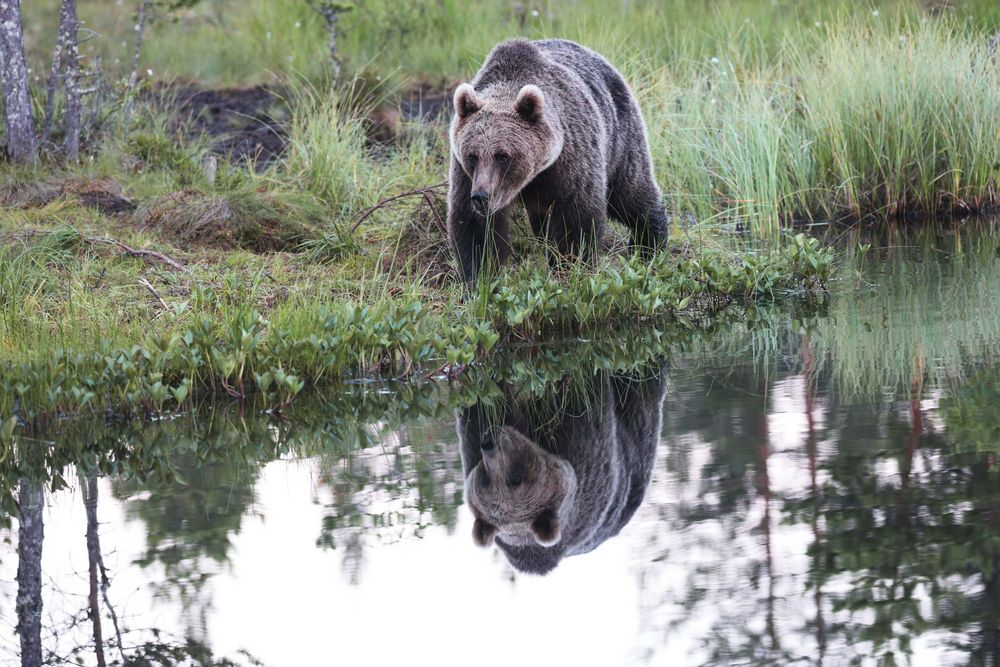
0;234;833;424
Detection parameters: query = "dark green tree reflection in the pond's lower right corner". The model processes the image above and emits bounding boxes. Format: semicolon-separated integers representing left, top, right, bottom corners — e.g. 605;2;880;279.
816;370;1000;665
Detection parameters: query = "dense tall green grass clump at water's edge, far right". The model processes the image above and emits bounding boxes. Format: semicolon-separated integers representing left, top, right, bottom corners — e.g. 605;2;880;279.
791;17;1000;216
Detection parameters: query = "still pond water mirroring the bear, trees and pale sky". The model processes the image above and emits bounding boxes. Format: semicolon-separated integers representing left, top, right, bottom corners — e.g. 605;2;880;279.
0;223;1000;667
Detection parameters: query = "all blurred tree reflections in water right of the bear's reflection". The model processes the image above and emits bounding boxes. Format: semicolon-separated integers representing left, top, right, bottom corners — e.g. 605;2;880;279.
640;336;1000;665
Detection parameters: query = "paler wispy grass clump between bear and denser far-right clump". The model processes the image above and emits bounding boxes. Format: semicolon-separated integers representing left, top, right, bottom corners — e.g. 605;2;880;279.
647;68;815;236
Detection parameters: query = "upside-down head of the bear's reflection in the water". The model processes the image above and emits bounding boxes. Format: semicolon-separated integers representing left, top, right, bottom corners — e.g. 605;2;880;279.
465;426;576;548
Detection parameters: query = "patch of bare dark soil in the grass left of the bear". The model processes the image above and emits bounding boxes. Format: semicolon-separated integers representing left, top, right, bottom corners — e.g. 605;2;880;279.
155;85;291;171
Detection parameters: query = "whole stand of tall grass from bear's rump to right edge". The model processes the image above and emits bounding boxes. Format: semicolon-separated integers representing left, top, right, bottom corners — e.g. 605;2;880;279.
643;16;1000;231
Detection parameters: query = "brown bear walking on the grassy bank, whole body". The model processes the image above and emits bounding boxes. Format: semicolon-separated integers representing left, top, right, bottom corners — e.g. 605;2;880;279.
448;39;667;286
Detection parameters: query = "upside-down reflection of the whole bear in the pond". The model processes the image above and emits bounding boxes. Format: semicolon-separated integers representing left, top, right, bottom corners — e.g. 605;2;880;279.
458;364;666;574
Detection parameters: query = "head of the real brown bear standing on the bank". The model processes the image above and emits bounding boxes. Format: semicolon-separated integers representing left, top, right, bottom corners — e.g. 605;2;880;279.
450;83;563;215
